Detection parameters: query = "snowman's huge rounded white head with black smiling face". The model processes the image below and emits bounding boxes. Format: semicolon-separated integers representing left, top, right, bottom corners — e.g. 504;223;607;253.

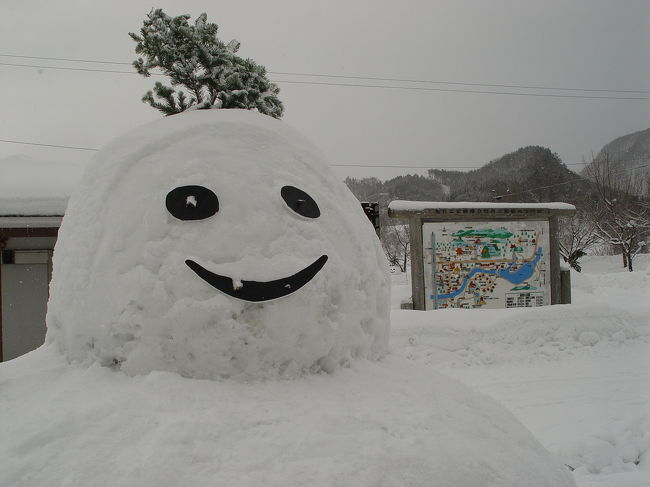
47;110;390;379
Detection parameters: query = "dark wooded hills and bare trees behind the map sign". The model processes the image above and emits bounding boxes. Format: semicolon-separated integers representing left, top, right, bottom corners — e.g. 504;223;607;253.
345;139;650;271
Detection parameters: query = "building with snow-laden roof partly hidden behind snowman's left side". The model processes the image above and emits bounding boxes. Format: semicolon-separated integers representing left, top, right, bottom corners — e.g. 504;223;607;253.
0;156;83;361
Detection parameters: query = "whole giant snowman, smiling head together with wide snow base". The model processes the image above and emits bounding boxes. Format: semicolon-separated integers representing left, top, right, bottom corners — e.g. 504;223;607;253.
0;110;575;487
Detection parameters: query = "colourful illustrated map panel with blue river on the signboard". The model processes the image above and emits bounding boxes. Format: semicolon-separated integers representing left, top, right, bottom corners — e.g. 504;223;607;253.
422;221;550;309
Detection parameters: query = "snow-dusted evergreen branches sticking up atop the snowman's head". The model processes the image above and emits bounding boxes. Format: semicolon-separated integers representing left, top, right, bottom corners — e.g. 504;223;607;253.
129;9;284;118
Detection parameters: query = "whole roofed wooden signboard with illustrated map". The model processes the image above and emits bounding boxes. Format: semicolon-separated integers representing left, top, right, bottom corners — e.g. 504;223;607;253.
388;201;575;310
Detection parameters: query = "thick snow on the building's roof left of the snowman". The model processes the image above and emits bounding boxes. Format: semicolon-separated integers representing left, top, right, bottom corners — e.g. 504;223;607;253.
0;155;84;217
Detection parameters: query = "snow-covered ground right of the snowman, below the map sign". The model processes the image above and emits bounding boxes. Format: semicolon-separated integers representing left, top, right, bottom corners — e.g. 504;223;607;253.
391;255;650;487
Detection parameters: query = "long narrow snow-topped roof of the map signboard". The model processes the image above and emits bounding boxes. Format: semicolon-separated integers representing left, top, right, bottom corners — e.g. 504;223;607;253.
388;200;576;218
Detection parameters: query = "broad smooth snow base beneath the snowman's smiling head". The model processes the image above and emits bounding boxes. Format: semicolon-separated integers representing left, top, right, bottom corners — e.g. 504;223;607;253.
0;347;575;487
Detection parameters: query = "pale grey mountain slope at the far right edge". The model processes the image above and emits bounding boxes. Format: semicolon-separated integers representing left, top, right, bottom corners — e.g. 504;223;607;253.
582;128;650;196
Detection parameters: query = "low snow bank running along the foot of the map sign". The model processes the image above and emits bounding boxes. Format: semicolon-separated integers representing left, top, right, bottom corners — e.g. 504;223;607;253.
391;304;650;367
